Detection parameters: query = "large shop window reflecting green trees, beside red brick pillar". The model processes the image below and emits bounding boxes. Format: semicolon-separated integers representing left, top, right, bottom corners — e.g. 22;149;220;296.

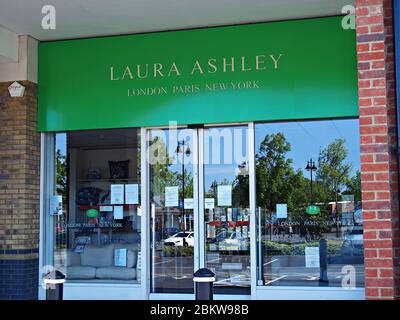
255;119;364;287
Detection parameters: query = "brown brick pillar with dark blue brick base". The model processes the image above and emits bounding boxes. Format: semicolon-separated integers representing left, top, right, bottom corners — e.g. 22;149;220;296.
0;81;40;300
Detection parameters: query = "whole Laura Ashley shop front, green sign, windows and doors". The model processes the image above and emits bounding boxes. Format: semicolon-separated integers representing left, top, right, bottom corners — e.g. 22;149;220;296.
39;17;365;300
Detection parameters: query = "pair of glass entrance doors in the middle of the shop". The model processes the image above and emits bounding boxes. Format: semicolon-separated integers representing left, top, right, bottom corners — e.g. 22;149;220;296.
148;125;251;295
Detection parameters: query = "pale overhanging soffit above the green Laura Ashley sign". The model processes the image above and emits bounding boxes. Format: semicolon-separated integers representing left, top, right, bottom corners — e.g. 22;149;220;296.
0;0;353;40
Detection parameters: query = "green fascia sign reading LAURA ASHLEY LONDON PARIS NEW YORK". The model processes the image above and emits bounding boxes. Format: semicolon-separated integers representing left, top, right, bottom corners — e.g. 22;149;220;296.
39;17;358;131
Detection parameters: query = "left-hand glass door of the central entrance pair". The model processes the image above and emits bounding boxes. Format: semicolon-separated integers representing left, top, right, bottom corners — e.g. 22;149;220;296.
148;129;198;294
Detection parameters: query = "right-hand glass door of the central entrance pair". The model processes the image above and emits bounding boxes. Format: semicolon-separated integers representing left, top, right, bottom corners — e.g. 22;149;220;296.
200;125;251;295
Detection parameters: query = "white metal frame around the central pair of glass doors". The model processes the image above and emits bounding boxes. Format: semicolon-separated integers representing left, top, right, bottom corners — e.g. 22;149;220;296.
145;122;257;300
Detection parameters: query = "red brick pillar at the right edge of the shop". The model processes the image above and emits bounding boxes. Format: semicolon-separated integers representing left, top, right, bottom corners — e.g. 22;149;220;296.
355;0;400;299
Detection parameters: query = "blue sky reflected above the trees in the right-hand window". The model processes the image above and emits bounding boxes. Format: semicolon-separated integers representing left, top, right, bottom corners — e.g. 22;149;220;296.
255;119;360;177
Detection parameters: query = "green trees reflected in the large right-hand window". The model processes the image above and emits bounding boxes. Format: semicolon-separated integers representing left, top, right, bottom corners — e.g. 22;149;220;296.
256;133;361;239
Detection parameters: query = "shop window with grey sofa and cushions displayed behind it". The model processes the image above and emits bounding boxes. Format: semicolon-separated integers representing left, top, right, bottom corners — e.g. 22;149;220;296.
49;129;141;283
